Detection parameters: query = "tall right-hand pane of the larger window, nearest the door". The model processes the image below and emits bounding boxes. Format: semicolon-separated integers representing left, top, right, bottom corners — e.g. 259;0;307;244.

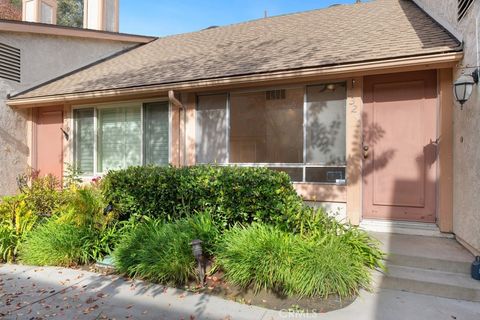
306;83;347;165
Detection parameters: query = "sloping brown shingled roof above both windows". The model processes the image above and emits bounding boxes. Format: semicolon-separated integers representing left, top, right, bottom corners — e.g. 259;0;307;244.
11;0;460;100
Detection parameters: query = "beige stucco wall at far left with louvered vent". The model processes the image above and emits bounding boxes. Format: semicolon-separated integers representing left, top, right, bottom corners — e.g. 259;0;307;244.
0;32;137;196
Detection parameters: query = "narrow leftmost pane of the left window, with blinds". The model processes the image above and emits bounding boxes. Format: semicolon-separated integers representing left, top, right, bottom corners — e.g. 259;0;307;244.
74;108;95;174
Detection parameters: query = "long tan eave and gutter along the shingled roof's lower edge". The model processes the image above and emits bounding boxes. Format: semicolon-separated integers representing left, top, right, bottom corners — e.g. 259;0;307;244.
7;51;463;108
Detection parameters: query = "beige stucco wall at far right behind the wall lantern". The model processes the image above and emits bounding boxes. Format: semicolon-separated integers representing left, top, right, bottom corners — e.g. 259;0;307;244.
415;0;480;252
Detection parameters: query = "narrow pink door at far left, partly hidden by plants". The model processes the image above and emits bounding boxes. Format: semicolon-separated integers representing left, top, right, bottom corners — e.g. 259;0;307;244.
36;107;63;181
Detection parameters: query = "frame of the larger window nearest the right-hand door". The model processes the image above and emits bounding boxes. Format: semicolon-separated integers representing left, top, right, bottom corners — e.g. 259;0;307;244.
195;79;349;186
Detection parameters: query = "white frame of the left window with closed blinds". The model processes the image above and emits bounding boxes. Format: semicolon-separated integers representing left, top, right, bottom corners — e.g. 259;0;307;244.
69;97;172;179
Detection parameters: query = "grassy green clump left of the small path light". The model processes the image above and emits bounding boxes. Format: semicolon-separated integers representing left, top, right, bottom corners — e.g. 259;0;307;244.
113;214;219;285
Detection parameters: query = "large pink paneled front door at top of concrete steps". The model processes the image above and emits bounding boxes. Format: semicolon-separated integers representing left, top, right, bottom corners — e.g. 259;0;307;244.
362;70;437;222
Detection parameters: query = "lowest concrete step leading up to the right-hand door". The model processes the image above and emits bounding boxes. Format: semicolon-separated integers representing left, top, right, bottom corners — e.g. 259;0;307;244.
374;265;480;302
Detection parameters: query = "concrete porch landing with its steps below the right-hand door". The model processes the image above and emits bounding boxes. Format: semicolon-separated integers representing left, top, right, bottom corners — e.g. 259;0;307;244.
369;231;480;301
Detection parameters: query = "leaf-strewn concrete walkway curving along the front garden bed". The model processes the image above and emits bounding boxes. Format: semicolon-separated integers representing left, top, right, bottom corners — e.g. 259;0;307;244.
0;265;480;320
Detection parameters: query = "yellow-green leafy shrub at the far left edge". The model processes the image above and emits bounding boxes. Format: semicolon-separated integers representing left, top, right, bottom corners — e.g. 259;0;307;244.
0;195;38;262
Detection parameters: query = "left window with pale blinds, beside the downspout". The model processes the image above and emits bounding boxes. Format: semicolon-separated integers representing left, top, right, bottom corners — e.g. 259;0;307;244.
74;102;169;175
